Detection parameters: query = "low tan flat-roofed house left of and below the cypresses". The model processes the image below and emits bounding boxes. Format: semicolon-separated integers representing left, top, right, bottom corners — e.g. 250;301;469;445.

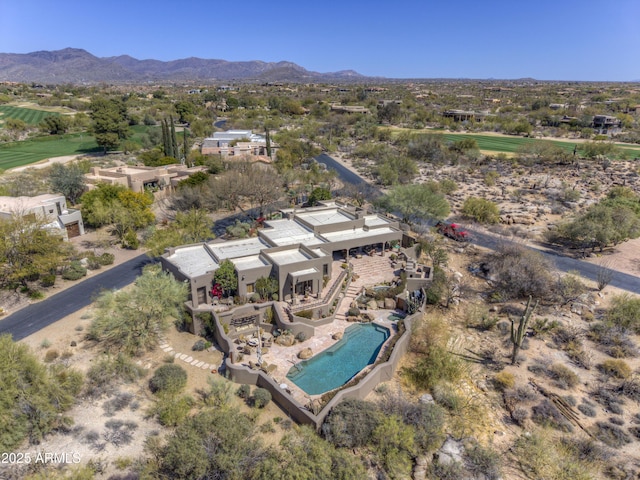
85;164;207;193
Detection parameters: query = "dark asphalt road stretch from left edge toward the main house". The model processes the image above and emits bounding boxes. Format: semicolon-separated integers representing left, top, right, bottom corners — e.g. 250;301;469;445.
0;254;151;340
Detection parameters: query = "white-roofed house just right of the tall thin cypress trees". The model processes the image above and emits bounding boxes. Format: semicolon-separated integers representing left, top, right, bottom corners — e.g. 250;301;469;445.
200;130;277;157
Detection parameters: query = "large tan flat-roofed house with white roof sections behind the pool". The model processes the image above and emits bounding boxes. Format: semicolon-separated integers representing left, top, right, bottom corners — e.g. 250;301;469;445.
160;201;410;324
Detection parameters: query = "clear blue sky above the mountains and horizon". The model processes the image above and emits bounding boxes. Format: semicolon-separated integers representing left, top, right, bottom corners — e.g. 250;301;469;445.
0;0;640;81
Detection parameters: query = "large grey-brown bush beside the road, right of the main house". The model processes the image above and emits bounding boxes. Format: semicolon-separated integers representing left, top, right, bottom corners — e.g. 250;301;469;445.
484;242;553;300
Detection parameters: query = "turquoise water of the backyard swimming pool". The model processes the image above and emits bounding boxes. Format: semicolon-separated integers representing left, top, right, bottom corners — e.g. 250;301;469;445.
287;323;390;395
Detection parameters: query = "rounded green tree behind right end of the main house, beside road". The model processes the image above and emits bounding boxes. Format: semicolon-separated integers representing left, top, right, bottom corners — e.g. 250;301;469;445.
379;183;449;222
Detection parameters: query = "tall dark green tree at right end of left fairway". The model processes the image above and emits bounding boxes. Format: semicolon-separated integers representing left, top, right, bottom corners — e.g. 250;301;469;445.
89;97;129;154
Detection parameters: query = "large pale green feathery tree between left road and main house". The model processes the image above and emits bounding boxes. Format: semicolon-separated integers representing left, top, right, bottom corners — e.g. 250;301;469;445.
89;265;187;355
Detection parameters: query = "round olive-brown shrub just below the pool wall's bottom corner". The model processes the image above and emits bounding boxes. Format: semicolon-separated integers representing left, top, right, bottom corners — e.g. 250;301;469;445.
322;399;380;448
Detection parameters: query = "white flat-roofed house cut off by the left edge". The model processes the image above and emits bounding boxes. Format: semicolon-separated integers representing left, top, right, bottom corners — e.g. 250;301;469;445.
0;193;84;240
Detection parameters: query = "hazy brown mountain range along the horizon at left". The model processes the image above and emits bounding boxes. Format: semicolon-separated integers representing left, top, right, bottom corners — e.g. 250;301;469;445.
0;48;366;84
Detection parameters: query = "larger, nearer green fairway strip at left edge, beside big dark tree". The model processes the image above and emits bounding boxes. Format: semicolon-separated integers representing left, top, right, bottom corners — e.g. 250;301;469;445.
0;133;101;170
